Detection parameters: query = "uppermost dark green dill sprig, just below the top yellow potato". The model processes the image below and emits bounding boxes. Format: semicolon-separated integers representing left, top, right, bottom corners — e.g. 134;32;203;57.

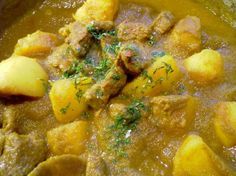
87;24;116;40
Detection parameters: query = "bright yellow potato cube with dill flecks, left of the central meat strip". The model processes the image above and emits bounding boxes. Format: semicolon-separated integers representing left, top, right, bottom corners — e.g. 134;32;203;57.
49;77;92;123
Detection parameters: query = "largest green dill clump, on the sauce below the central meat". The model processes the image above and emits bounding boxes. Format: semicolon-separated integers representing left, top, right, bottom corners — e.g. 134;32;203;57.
109;100;147;157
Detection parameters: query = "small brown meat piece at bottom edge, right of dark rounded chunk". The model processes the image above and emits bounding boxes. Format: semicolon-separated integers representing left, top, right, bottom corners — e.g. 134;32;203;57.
86;154;108;176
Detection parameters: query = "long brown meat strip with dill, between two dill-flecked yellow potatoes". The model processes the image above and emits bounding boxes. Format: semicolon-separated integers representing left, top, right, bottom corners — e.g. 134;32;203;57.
84;66;127;109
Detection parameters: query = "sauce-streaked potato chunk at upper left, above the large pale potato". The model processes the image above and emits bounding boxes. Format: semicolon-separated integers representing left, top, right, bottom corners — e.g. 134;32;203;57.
14;31;60;57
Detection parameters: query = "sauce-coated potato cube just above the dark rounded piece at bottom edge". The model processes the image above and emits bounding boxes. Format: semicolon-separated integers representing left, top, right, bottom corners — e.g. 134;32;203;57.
47;121;89;155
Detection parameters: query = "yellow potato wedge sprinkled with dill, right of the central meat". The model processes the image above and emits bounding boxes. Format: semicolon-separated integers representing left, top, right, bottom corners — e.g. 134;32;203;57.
122;55;181;98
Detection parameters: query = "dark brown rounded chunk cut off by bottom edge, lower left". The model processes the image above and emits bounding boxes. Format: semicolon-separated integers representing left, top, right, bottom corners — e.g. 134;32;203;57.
28;155;86;176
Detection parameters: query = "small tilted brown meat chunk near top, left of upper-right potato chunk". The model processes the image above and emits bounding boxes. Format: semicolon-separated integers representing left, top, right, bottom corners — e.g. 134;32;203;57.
151;11;175;38
